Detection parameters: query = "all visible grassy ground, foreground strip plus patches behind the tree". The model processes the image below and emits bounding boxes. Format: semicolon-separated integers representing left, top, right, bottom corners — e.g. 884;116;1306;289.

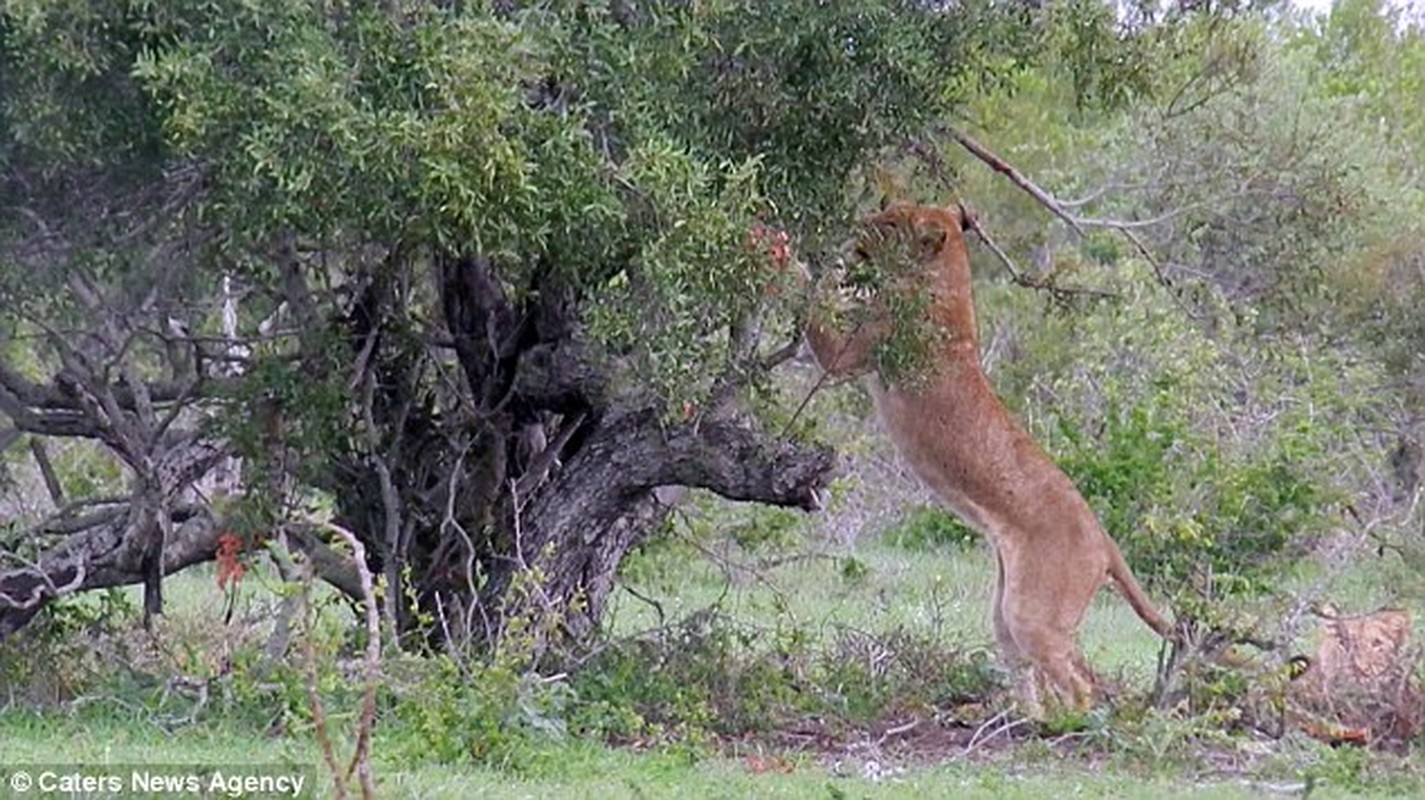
0;513;1425;799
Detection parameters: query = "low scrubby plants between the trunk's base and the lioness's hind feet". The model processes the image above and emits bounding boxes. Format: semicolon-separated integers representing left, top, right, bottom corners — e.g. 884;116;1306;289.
573;610;996;742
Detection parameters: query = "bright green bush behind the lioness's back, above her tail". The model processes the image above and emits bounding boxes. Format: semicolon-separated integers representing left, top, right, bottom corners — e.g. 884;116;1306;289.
986;259;1368;593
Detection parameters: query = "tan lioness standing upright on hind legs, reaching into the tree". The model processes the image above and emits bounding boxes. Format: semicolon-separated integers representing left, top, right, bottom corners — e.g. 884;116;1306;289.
807;205;1171;713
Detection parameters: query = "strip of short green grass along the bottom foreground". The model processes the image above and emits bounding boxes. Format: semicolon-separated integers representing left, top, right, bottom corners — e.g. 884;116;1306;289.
0;712;1419;800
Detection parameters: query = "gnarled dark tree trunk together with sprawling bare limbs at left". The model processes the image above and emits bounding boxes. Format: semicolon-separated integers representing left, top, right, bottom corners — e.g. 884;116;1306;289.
0;246;835;647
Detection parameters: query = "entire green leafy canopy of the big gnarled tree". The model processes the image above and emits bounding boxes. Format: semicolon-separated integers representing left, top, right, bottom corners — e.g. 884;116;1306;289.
0;0;1060;408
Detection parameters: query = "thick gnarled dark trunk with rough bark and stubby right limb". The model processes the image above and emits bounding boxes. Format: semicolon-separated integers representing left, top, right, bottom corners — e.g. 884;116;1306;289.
319;250;835;655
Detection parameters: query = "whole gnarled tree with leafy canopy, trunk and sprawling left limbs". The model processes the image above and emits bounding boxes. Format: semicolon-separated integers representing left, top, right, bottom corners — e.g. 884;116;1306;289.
0;0;1033;642
